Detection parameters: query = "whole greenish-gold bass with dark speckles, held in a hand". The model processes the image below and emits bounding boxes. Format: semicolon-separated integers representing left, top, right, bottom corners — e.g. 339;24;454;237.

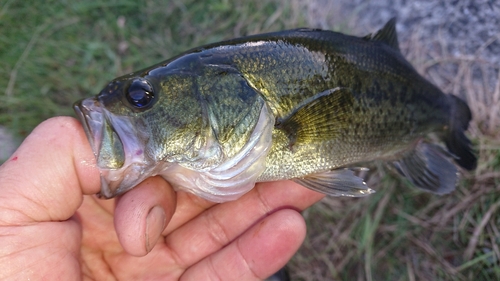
74;18;477;202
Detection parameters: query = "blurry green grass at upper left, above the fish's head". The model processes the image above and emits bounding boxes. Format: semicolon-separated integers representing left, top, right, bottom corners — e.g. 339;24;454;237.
0;0;304;137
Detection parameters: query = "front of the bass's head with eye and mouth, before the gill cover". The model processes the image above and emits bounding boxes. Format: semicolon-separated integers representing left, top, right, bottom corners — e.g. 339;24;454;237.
74;71;208;198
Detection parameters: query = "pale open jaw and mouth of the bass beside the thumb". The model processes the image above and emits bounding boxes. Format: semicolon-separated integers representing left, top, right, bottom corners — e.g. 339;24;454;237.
74;98;168;198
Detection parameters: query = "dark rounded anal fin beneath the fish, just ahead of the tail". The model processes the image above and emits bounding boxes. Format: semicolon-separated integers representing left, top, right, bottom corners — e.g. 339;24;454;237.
394;142;458;194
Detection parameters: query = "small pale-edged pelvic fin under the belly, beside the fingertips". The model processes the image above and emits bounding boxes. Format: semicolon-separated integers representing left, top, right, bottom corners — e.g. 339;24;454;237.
292;169;375;197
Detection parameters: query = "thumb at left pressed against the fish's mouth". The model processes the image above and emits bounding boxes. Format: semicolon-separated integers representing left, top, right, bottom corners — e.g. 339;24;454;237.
0;117;100;225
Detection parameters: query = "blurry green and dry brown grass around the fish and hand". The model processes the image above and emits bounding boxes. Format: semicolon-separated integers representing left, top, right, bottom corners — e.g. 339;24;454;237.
0;0;500;280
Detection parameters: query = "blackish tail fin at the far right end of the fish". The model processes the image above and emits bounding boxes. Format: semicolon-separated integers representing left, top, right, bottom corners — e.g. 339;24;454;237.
444;95;477;171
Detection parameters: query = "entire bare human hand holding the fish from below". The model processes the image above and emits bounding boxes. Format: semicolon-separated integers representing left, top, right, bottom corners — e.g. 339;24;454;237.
0;117;323;280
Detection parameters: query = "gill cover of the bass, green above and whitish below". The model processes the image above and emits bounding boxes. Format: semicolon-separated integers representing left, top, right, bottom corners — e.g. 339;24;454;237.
160;64;274;202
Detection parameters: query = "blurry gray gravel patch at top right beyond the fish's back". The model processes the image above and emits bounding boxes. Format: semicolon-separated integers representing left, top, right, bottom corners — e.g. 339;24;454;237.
307;0;500;88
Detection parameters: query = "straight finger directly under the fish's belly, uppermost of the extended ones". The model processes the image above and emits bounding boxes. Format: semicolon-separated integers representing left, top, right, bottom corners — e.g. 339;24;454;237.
165;181;324;268
